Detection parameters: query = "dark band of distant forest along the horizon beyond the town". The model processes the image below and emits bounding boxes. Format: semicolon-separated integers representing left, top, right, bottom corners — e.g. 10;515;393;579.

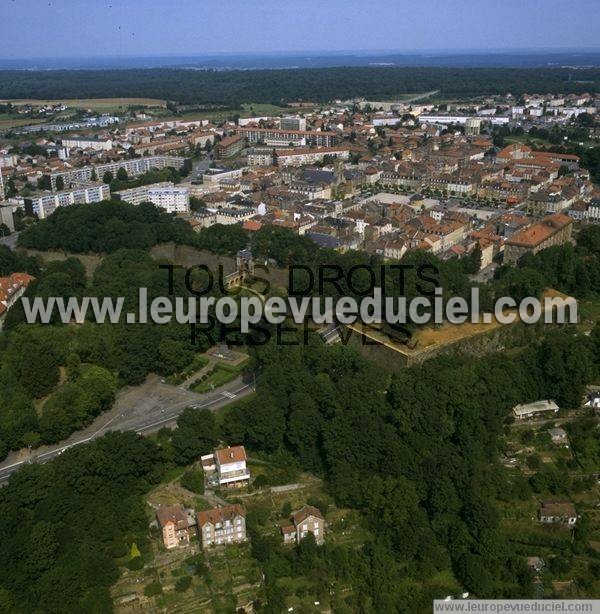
0;67;600;106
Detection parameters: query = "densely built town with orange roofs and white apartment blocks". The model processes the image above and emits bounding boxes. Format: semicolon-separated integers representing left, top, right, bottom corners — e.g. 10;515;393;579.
0;95;600;269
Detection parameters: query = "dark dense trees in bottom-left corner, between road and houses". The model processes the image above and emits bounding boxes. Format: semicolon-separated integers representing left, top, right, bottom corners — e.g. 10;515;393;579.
0;433;164;614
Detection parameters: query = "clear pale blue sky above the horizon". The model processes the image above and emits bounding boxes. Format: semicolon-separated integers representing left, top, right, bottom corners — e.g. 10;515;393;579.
0;0;600;59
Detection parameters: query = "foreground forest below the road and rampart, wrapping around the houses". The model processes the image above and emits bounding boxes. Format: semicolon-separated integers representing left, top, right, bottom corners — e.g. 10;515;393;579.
0;327;600;614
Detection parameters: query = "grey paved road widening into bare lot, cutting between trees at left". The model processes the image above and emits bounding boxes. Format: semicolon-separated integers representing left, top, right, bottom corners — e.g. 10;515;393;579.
0;375;254;484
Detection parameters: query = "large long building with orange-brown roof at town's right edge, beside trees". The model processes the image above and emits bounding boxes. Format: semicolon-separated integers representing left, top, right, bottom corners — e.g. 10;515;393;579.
504;213;573;263
